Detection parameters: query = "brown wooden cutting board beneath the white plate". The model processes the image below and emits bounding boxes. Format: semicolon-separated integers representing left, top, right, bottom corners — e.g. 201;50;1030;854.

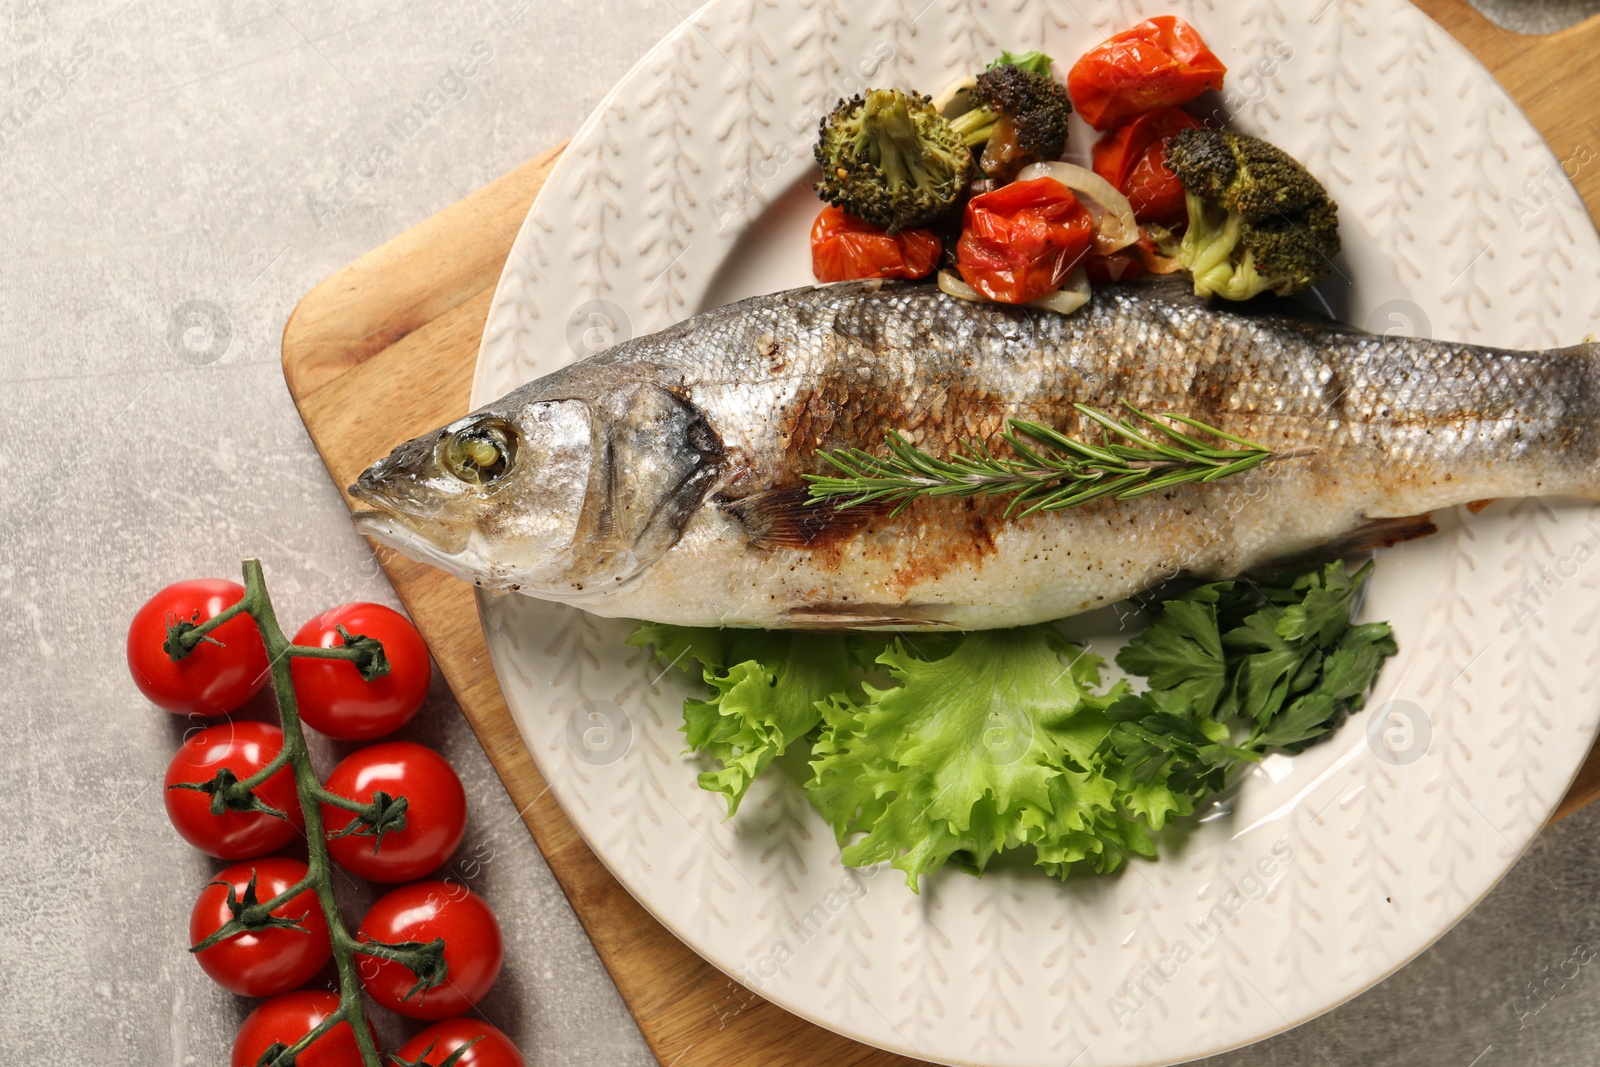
283;0;1600;1067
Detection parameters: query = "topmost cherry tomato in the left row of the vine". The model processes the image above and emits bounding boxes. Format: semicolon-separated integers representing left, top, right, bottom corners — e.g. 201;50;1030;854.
128;577;267;717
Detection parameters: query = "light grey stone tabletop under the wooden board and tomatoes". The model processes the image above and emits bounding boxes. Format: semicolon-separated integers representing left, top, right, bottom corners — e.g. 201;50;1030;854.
0;0;1600;1067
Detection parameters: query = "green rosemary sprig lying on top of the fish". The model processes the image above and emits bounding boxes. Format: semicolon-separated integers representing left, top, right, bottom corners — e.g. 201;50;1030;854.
805;402;1315;515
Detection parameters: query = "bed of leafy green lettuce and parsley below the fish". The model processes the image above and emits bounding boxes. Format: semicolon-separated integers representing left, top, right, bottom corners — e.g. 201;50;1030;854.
629;563;1395;889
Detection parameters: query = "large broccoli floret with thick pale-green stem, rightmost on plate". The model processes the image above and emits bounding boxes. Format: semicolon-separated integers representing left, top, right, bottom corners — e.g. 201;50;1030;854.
1155;130;1339;301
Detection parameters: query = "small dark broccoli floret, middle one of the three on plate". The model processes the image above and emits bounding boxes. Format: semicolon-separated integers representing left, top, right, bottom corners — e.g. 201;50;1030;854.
950;56;1072;181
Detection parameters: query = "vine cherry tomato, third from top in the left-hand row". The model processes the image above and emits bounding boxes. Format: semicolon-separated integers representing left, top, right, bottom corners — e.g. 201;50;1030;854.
189;856;333;997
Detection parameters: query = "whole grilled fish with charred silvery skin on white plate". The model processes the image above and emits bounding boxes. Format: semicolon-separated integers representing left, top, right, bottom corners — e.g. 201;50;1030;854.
352;282;1600;629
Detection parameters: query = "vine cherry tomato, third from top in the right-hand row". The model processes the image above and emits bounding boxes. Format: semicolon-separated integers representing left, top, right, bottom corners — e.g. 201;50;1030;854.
355;881;506;1019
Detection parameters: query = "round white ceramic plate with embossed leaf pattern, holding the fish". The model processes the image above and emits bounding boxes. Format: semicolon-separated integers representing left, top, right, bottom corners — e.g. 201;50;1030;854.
474;0;1600;1067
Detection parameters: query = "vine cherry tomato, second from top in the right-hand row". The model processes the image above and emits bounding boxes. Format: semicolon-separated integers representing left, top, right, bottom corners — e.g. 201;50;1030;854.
322;741;467;881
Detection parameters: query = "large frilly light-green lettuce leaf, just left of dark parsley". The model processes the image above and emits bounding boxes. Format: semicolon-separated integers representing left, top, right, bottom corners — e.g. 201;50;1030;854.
806;625;1186;889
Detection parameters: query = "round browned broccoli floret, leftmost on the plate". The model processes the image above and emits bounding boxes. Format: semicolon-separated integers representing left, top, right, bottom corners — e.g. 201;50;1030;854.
816;90;973;234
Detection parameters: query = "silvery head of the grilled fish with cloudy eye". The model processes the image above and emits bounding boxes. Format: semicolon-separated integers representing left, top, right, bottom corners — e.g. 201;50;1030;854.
349;382;722;600
